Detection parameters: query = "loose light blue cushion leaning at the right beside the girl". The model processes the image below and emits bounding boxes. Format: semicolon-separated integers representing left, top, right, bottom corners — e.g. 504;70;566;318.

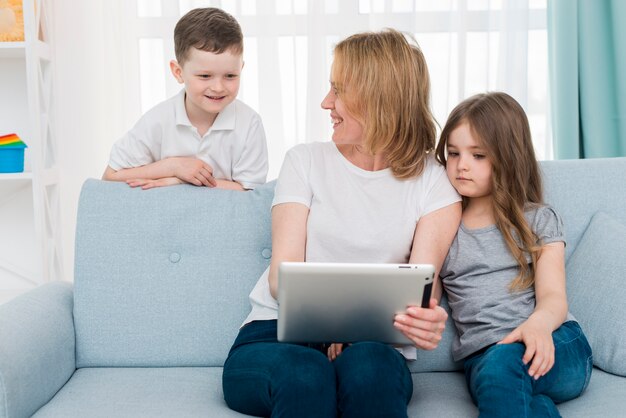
567;212;626;376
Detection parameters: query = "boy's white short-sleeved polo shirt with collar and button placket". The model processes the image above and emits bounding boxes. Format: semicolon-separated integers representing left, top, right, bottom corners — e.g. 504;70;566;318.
109;89;268;189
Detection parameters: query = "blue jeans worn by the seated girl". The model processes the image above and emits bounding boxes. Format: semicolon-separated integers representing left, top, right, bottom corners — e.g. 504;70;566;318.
464;321;593;418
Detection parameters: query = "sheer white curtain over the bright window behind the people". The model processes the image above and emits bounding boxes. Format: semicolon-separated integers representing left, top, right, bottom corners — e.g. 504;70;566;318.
117;0;552;178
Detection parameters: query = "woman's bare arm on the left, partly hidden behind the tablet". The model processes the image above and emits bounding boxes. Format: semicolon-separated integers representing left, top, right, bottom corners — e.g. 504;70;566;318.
268;203;309;300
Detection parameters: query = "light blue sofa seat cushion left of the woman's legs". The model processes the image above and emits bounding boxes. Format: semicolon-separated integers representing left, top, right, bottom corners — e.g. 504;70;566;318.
33;367;246;418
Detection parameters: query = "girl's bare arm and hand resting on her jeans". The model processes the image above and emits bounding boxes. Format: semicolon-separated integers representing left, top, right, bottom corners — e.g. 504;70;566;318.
500;242;568;379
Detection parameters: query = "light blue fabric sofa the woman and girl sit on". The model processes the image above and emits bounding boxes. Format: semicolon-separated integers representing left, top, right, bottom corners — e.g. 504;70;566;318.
0;158;626;418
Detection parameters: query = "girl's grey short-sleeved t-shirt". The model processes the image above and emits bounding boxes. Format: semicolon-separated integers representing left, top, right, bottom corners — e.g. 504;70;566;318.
440;206;573;361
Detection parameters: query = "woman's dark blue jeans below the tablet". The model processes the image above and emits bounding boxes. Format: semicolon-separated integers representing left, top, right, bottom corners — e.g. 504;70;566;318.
222;320;413;418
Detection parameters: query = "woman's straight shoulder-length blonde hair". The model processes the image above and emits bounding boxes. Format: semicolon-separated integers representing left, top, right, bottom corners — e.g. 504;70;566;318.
331;29;436;179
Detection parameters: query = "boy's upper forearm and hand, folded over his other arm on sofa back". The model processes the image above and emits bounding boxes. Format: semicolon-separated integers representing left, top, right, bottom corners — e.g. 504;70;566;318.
102;157;217;187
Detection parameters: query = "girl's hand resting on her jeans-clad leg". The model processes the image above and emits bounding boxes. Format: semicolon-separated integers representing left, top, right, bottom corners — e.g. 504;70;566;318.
498;316;554;380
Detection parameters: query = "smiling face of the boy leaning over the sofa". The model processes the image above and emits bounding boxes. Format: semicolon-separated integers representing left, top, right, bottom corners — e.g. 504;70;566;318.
170;48;243;126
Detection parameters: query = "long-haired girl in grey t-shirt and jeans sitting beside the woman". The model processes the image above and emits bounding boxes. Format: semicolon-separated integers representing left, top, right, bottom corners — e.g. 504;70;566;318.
436;93;592;417
